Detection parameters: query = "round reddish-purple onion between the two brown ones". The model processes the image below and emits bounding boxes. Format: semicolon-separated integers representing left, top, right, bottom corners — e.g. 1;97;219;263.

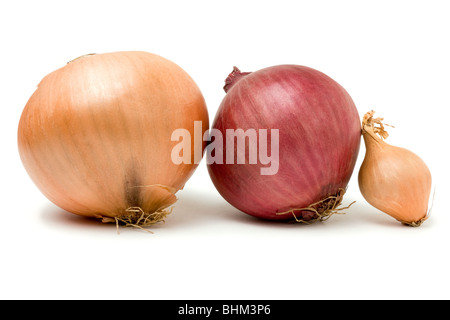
208;65;361;220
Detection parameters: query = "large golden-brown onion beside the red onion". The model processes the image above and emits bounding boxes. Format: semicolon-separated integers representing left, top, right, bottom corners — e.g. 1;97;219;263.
18;52;209;226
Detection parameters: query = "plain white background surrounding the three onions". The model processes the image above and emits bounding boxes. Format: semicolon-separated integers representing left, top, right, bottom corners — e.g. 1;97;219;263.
0;0;450;299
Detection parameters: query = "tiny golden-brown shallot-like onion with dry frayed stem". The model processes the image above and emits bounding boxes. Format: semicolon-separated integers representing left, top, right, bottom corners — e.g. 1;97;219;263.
358;111;431;227
